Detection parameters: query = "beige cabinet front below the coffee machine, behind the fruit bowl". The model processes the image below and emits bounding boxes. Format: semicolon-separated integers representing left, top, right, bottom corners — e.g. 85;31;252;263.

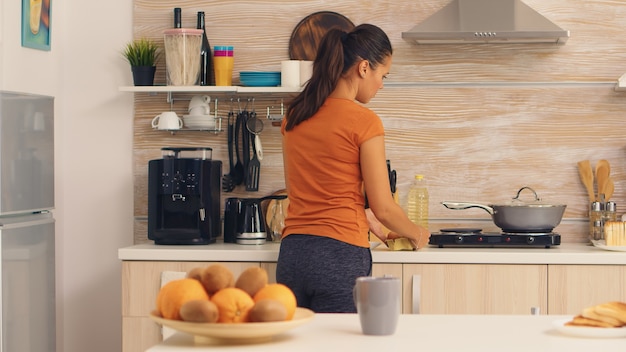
122;261;259;352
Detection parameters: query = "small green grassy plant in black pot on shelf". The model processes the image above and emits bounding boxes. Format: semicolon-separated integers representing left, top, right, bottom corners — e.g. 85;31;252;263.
123;38;161;86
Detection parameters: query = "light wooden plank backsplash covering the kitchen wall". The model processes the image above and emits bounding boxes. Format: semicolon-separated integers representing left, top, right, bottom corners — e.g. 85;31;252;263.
129;0;626;243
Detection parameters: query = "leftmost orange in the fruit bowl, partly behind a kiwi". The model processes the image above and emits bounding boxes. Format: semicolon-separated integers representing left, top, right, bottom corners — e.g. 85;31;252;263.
156;278;209;320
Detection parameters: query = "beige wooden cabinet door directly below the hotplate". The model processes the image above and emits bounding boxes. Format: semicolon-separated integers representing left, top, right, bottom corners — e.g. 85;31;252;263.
403;264;547;314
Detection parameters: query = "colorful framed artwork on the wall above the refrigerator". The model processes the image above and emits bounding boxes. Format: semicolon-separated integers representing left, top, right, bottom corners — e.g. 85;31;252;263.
22;0;51;51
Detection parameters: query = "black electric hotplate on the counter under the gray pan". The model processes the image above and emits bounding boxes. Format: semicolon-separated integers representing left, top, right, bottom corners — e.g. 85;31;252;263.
428;228;561;248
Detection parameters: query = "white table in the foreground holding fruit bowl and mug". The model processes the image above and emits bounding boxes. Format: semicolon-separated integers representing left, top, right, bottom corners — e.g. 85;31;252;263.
147;314;626;352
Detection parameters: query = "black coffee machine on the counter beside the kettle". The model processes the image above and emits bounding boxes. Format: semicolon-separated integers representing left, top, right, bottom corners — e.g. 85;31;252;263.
148;147;222;245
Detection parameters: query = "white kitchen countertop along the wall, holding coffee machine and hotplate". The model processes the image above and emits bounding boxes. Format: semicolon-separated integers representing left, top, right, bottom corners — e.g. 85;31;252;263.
118;242;626;265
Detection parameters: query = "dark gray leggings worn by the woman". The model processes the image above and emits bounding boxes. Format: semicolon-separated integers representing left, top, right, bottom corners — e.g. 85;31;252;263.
276;235;372;313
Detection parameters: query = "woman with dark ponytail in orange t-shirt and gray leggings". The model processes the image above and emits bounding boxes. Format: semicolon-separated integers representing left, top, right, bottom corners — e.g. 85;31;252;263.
276;24;429;313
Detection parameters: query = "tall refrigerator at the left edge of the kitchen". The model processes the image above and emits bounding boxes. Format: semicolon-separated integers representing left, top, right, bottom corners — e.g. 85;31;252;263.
0;91;56;352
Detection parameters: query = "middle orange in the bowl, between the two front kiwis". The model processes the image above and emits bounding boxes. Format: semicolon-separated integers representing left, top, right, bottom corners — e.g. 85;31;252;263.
211;287;254;323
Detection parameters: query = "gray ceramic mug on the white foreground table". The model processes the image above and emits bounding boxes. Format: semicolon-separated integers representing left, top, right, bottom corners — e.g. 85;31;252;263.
353;276;401;335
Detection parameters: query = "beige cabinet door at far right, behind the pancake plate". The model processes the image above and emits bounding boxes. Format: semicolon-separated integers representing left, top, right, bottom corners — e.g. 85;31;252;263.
548;265;626;315
